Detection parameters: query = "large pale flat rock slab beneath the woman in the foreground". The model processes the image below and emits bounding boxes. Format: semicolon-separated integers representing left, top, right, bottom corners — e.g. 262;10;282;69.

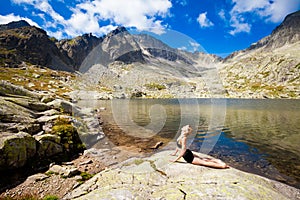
64;151;300;200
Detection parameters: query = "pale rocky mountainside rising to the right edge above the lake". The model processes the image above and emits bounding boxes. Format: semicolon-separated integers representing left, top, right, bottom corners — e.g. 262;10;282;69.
219;11;300;98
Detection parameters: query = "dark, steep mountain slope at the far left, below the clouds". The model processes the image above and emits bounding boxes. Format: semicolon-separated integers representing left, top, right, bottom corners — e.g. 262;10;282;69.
0;21;74;71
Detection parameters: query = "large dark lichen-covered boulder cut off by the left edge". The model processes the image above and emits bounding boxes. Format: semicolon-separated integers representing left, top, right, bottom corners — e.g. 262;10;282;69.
0;132;36;170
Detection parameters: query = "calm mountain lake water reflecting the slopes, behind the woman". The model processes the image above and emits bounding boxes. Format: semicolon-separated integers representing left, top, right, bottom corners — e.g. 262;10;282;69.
97;99;300;188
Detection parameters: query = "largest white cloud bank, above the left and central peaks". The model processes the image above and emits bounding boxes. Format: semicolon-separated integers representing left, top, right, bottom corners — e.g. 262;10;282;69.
12;0;172;36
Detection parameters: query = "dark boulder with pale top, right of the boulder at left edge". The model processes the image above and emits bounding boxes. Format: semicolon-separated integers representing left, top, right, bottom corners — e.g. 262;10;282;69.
34;134;63;157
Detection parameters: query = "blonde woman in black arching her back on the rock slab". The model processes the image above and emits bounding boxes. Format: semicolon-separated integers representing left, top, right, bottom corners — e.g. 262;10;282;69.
172;125;229;169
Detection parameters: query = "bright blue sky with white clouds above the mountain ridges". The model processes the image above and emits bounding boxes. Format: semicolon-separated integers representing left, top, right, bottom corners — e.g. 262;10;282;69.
0;0;300;57
